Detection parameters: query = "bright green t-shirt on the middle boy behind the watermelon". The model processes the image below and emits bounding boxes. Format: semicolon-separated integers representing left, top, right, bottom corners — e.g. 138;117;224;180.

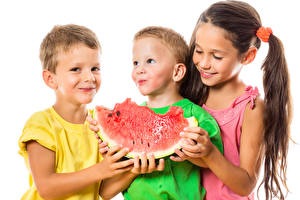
123;99;223;200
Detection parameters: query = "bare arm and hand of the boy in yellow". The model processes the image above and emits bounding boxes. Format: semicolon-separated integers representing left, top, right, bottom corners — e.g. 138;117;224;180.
27;141;132;199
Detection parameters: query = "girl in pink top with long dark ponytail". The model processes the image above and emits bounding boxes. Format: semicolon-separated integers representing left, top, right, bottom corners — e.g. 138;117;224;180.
180;1;291;200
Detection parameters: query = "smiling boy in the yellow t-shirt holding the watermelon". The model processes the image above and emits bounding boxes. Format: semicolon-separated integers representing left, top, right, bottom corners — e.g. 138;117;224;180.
19;25;133;200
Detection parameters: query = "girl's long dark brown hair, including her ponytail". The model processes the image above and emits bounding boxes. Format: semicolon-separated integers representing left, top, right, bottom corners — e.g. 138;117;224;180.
180;1;292;199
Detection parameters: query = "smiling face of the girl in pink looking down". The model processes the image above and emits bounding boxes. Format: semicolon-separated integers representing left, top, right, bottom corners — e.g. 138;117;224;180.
193;23;242;86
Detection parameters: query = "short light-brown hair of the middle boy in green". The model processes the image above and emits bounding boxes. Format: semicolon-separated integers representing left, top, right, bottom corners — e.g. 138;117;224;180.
134;26;189;65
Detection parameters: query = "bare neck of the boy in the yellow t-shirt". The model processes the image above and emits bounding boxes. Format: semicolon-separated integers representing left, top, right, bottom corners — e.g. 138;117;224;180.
53;101;88;124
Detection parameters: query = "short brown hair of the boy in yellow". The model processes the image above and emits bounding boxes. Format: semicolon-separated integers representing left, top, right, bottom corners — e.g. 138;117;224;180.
40;24;101;73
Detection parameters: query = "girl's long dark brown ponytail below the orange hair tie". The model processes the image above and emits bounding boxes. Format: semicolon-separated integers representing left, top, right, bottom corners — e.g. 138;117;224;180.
259;34;292;199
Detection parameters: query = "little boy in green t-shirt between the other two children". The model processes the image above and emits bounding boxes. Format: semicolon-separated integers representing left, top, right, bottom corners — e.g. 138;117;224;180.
91;27;223;200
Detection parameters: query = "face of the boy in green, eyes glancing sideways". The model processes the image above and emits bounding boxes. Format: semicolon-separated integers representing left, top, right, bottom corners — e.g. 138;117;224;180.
132;37;176;96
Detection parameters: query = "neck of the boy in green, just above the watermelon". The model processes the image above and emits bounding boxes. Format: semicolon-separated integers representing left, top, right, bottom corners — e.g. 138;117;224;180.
147;92;183;108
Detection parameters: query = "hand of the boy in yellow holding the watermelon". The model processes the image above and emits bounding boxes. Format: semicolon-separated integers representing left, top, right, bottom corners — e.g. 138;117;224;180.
99;145;134;179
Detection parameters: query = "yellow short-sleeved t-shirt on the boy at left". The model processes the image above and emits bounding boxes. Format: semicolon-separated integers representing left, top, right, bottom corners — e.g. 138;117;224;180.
19;107;101;200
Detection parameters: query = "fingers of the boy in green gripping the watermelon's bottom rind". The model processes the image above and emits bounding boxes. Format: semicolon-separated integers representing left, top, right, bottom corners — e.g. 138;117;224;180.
131;153;165;174
